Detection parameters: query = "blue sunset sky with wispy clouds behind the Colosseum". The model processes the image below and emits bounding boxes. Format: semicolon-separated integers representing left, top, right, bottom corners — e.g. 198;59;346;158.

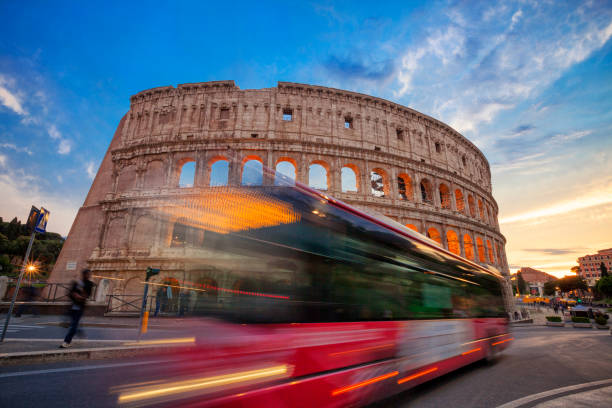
0;1;612;276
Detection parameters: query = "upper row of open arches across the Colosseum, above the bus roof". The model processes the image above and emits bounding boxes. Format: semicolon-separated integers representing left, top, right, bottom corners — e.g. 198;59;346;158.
167;155;496;225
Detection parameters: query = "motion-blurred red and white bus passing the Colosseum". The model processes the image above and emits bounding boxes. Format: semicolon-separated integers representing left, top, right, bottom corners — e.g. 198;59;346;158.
118;180;512;407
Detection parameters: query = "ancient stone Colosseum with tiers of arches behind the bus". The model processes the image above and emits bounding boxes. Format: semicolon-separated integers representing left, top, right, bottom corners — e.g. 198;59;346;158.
51;81;512;316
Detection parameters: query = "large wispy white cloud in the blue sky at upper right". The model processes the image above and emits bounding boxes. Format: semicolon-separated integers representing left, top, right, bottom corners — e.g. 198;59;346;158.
395;1;612;135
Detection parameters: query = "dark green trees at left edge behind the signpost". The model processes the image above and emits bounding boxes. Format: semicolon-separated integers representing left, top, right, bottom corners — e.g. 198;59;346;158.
0;217;64;279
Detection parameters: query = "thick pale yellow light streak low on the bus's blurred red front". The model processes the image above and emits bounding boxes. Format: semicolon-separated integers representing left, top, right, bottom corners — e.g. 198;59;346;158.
118;365;288;403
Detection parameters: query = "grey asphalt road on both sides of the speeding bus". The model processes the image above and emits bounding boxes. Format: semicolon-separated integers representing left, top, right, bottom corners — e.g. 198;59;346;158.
0;327;612;408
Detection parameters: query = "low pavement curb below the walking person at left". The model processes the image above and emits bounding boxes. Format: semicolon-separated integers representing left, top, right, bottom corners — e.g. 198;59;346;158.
0;345;192;365
